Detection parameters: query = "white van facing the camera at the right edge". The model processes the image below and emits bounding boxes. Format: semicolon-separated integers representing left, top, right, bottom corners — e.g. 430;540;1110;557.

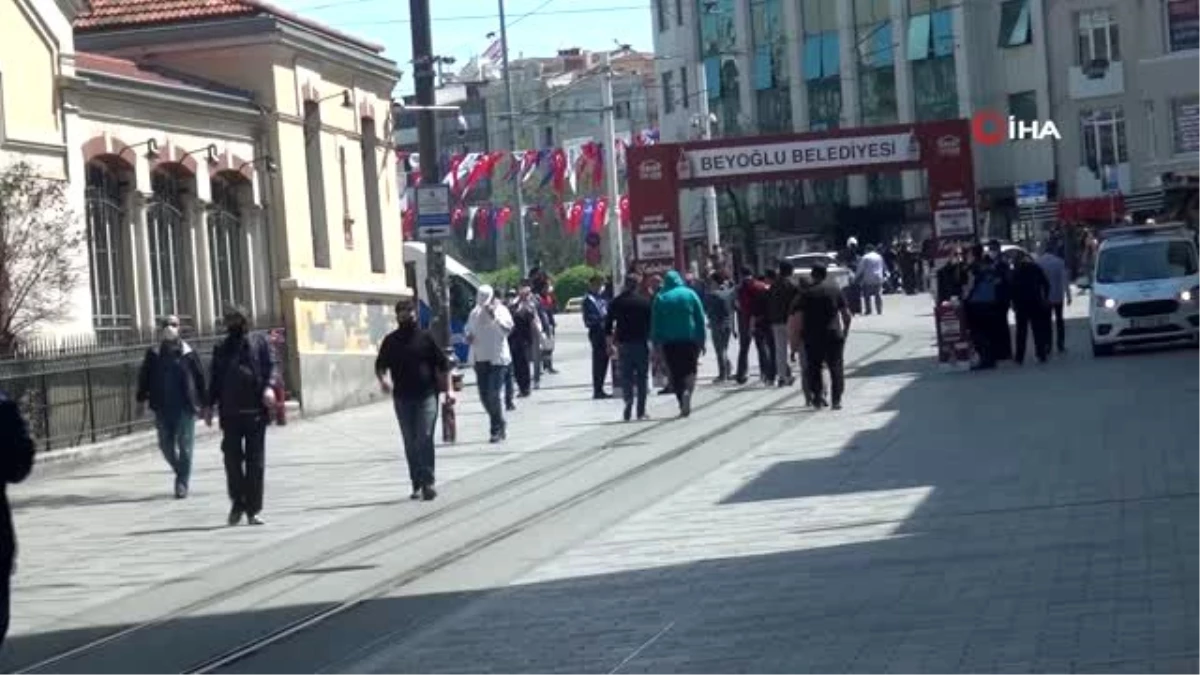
1090;225;1200;357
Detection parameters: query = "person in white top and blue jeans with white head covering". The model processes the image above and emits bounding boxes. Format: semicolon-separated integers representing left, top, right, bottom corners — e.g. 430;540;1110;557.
463;285;512;443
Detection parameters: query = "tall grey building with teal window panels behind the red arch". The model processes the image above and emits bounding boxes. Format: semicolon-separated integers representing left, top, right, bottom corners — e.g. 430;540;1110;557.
652;0;1055;248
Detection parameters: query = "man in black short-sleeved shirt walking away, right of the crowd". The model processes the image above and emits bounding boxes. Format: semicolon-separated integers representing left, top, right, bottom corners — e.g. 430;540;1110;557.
792;263;852;410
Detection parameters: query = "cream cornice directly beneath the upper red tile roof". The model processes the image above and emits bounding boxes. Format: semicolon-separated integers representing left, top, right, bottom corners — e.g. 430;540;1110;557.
76;16;401;90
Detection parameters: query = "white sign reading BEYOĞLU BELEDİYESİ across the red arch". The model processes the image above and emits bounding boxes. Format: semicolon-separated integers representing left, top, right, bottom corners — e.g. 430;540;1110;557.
678;132;920;186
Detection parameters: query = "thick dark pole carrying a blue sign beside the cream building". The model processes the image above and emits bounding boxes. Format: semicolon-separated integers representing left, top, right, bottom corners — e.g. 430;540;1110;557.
408;0;454;358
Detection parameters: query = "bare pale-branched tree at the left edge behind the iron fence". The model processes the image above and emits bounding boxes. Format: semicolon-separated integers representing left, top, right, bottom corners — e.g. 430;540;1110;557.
0;162;86;354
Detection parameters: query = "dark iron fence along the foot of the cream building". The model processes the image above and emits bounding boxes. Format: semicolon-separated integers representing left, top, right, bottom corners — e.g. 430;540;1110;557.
0;321;294;452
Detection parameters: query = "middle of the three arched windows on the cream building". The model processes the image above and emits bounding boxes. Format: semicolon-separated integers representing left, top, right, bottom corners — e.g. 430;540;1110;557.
146;168;193;325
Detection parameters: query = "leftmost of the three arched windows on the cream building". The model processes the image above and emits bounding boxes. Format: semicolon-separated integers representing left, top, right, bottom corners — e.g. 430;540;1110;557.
86;160;133;333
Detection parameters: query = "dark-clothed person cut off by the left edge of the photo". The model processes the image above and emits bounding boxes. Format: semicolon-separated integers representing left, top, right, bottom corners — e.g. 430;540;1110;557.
0;392;35;646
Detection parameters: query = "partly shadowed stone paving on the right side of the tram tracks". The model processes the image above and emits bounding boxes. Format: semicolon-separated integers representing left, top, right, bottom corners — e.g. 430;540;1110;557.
340;299;1200;675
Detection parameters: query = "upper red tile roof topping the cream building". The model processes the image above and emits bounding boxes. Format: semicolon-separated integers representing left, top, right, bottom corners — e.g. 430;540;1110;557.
74;0;384;54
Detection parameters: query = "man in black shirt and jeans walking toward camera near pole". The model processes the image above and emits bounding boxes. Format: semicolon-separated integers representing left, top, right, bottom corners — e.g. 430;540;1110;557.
376;298;454;501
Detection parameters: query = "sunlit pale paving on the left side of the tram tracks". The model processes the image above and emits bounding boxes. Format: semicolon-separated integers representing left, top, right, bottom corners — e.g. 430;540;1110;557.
0;324;648;638
